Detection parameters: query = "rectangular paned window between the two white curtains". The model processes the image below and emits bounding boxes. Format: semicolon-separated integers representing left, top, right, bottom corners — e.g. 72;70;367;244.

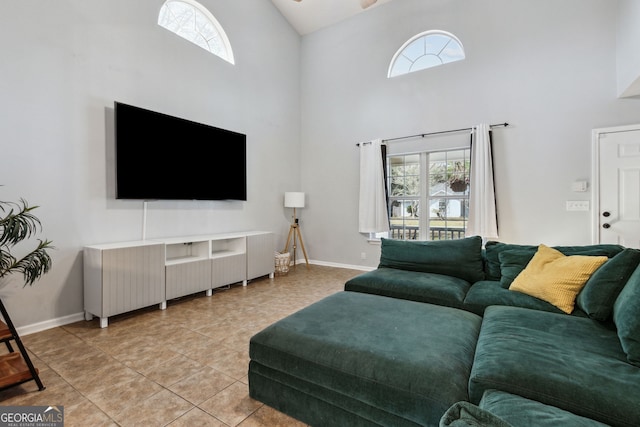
387;148;470;240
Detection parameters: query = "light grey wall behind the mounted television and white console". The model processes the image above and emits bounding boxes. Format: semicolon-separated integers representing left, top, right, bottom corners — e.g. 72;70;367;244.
0;0;300;326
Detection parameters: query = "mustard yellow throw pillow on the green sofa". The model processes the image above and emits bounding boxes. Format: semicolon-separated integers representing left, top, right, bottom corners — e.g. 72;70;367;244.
509;245;608;314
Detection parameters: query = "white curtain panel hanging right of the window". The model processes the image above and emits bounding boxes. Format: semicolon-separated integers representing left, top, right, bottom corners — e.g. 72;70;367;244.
467;124;498;240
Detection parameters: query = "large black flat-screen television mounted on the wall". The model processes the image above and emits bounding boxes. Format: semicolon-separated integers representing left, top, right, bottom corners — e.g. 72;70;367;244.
114;102;247;200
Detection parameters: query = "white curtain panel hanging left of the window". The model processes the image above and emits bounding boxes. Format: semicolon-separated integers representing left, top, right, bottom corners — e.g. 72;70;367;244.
358;139;389;233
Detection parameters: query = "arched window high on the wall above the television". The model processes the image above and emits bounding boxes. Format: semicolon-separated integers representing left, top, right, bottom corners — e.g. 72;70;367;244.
158;0;235;64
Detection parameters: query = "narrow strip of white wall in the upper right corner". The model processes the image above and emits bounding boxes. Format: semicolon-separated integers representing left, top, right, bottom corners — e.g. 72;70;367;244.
617;0;640;96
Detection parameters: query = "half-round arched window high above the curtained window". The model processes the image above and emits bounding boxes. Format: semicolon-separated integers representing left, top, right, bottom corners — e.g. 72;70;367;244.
387;30;464;78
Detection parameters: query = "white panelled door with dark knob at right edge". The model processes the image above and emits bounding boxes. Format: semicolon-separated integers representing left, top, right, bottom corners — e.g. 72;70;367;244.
593;125;640;248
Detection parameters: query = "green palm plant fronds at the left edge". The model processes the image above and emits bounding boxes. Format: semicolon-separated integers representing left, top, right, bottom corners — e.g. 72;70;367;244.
0;199;53;288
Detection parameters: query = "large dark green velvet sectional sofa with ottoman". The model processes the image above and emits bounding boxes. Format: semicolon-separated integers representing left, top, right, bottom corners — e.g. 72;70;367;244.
249;237;640;426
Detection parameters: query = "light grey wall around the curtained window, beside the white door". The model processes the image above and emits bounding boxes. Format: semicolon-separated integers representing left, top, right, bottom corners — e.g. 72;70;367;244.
300;0;640;266
